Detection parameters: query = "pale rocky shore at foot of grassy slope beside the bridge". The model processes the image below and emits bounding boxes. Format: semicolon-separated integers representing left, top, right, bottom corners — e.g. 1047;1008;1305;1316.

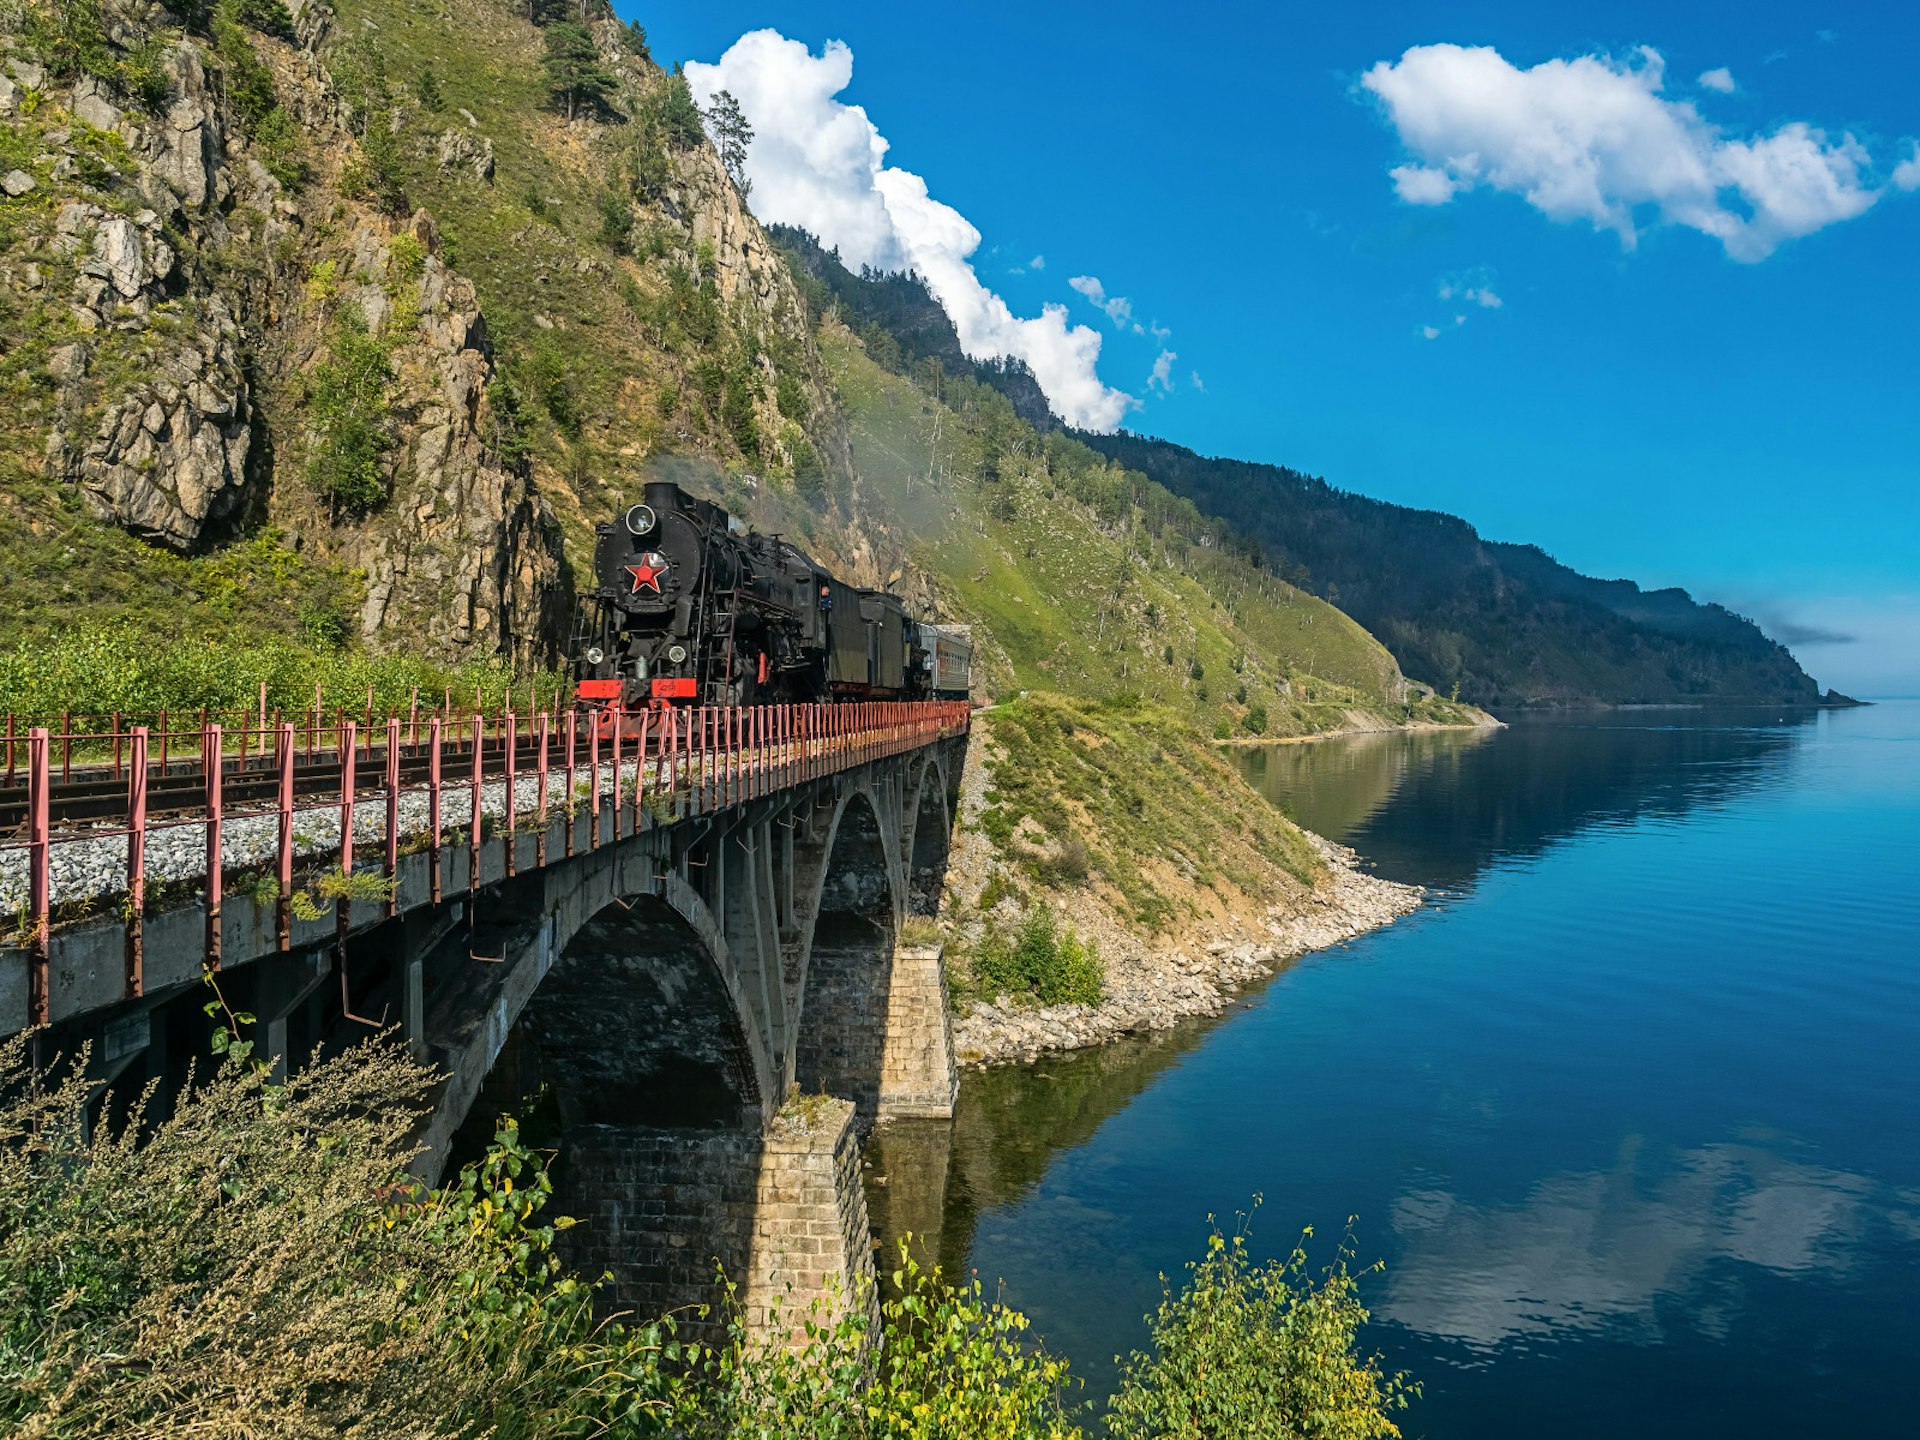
954;835;1425;1066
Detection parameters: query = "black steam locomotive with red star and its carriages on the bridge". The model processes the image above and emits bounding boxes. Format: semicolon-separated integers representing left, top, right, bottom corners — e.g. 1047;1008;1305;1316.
574;480;972;712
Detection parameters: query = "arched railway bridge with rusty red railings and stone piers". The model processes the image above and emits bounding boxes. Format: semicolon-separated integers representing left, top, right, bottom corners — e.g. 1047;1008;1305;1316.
0;703;968;1336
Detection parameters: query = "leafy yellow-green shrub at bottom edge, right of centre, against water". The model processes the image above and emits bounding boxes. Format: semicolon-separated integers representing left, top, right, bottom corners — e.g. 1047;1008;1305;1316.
1106;1221;1419;1440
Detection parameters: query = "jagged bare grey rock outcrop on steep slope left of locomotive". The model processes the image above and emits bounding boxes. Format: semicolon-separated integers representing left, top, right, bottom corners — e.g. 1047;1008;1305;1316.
11;0;572;664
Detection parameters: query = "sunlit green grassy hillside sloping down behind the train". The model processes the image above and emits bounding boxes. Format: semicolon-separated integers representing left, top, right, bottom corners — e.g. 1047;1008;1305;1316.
822;326;1465;735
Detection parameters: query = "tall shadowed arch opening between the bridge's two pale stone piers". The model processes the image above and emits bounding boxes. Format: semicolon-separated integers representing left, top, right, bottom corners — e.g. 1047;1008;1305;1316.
793;789;904;1119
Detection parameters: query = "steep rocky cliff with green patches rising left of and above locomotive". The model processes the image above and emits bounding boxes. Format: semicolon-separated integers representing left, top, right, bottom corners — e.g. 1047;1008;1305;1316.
0;0;847;664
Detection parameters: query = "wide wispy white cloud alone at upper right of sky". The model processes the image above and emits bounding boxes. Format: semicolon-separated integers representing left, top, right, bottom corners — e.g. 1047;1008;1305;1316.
1361;44;1882;261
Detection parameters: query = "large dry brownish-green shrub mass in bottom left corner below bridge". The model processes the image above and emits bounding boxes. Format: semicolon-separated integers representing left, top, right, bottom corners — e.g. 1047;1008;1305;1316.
0;1016;683;1440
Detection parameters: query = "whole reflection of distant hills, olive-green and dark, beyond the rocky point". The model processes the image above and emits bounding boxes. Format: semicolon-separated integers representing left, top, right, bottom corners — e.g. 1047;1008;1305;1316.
1242;710;1818;887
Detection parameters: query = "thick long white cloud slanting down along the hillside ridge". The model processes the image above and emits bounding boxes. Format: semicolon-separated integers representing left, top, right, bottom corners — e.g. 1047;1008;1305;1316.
685;31;1137;430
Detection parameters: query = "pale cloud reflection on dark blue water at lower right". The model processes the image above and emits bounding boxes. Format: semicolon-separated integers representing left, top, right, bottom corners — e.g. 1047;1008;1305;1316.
1379;1135;1874;1350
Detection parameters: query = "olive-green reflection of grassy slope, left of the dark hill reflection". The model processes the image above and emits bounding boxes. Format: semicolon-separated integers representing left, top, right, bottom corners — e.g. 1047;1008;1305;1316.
1233;730;1494;839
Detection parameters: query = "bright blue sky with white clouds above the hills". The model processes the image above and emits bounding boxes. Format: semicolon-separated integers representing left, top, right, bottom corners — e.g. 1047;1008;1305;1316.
616;0;1920;695
